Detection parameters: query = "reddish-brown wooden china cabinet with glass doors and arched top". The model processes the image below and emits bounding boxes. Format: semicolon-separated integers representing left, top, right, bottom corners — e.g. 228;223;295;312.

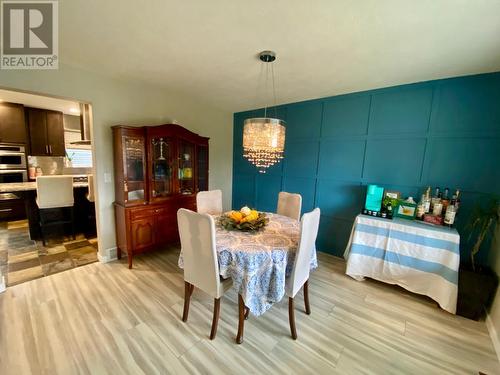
113;124;208;268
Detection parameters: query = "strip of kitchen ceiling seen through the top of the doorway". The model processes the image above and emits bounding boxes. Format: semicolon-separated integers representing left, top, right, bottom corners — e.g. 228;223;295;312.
0;89;80;116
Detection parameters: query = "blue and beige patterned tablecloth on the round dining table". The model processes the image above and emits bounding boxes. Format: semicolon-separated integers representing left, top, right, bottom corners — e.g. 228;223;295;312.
179;213;318;315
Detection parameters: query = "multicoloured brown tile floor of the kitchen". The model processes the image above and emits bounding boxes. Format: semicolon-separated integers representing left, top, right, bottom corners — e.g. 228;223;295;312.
0;220;97;286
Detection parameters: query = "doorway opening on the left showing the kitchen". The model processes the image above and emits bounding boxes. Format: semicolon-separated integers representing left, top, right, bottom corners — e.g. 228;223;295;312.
0;89;98;291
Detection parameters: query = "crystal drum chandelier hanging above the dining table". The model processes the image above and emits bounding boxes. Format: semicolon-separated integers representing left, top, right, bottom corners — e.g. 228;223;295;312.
243;51;285;173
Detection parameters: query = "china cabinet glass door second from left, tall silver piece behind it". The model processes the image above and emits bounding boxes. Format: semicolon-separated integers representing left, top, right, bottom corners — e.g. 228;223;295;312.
151;137;174;199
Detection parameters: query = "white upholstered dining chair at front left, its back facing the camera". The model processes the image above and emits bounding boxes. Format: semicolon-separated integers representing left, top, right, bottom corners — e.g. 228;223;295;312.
177;208;232;340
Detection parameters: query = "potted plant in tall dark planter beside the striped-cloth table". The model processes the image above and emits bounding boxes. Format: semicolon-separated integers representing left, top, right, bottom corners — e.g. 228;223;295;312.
457;197;500;320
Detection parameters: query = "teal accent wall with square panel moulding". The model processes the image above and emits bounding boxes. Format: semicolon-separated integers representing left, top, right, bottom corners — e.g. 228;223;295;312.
232;73;500;262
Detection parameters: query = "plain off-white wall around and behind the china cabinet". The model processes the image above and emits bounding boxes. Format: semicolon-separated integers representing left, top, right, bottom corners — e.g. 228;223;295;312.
0;64;233;256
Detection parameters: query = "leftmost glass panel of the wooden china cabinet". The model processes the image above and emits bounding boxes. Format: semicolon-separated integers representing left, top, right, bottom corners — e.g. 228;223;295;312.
123;136;145;202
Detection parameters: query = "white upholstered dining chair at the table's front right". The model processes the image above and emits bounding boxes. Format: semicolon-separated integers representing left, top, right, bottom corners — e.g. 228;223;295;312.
285;208;321;340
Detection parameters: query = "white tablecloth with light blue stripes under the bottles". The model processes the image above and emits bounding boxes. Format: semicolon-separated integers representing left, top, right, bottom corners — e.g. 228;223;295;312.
344;215;460;314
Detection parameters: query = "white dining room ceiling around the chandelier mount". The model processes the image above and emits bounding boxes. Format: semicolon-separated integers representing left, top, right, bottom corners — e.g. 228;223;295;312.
59;0;500;111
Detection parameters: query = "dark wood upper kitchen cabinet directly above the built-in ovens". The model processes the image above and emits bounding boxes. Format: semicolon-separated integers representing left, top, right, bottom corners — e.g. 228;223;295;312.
0;103;27;144
